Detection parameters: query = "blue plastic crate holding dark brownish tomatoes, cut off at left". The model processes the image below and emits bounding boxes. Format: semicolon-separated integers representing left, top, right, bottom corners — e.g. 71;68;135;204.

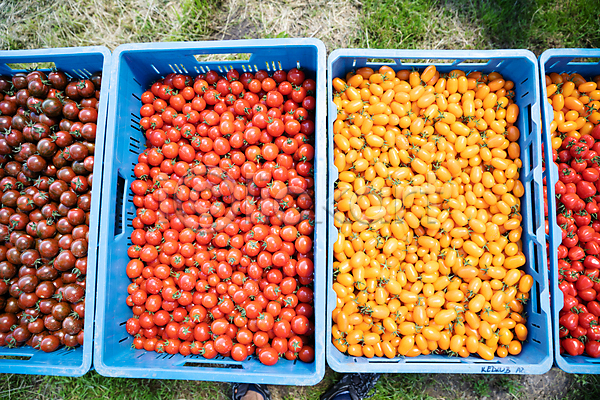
0;46;111;376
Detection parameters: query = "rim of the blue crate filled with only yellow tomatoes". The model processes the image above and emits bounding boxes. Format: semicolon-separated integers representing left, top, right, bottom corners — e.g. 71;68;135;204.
326;49;553;374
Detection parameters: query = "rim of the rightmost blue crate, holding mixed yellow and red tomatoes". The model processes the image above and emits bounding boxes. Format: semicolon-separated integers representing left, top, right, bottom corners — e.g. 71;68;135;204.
539;48;600;374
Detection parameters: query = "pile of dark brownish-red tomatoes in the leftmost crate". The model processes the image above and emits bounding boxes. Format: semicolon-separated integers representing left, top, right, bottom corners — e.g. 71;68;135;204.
0;70;101;352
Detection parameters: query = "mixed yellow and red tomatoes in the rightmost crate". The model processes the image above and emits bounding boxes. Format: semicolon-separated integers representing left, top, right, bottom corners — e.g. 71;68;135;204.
546;73;600;357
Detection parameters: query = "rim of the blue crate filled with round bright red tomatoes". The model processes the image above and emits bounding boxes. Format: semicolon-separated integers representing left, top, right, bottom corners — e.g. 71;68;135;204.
94;39;327;385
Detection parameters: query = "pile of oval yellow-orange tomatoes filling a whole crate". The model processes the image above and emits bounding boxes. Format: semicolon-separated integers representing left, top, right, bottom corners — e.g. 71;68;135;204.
331;66;533;360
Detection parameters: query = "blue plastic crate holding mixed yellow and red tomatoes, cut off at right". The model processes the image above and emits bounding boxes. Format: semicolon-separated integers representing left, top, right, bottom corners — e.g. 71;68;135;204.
539;49;600;374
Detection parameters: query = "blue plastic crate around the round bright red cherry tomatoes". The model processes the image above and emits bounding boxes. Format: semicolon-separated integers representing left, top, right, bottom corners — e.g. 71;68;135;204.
94;39;326;385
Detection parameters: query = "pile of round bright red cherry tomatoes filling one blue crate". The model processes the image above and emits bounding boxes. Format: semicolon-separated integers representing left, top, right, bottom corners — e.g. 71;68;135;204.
126;69;316;365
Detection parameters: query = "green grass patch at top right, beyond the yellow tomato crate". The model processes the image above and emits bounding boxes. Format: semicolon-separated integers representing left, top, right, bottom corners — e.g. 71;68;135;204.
354;0;600;54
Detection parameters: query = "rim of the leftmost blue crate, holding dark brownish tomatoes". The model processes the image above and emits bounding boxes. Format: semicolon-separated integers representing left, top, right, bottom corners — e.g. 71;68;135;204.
0;46;112;377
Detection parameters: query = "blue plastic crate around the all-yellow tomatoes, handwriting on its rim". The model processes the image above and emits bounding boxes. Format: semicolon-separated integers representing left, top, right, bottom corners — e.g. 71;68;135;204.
326;49;552;374
